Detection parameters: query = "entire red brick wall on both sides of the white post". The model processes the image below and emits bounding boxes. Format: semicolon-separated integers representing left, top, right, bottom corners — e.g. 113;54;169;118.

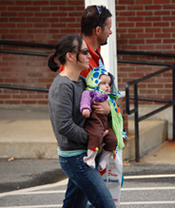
0;0;175;105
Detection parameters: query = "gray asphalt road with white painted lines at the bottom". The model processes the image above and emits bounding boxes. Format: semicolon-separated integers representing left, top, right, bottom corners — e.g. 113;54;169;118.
0;163;175;208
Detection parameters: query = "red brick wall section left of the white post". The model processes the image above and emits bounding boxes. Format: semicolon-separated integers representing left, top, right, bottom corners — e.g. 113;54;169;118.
0;0;84;105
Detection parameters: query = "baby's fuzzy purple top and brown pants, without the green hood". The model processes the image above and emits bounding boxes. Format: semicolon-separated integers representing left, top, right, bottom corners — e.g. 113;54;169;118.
80;85;117;152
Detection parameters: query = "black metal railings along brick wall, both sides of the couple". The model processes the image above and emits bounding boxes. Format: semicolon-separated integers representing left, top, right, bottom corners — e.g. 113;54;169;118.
0;40;175;162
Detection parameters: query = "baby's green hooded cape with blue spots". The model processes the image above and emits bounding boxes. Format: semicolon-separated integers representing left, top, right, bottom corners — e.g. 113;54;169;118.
86;60;125;150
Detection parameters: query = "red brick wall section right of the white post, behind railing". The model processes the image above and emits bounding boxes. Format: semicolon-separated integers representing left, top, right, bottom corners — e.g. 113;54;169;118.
116;0;175;103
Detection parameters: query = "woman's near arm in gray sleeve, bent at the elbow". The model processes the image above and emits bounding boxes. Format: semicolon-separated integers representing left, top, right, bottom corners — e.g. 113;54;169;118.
49;83;88;144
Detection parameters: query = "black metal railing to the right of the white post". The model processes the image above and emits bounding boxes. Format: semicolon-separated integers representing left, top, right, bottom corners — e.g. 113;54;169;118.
117;50;175;162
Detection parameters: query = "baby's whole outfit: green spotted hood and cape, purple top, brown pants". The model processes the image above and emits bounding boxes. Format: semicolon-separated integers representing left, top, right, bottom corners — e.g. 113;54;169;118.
80;60;124;167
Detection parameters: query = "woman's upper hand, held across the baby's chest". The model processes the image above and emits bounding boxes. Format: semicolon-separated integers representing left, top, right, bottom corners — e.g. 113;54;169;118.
92;100;111;115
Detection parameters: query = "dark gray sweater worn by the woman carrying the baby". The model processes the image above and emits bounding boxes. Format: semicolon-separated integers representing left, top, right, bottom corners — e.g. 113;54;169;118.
49;75;88;151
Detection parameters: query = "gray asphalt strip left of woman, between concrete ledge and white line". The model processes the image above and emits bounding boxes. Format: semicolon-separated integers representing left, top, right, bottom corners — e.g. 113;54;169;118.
0;158;66;193
